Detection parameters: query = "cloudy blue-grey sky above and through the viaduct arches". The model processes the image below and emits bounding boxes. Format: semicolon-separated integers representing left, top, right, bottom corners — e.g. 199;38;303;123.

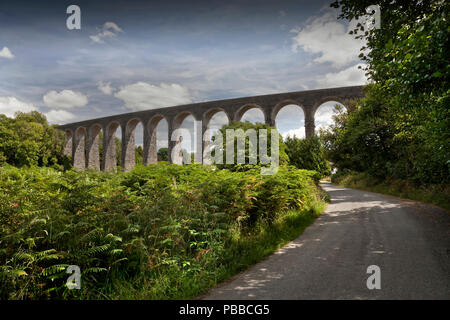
0;0;366;147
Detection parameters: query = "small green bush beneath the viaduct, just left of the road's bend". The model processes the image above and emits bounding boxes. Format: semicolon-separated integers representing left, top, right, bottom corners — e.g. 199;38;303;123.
285;137;331;177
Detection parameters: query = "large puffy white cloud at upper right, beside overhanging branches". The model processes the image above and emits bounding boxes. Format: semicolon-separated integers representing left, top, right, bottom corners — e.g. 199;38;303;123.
291;12;364;68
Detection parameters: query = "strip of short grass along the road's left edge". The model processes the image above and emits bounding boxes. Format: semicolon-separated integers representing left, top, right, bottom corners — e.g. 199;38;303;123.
109;201;325;300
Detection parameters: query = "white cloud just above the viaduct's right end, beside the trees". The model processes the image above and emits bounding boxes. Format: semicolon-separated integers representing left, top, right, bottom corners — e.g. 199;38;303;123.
316;63;367;88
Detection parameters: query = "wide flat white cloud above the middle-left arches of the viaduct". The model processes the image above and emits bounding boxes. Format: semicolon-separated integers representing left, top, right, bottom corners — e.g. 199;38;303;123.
114;82;192;111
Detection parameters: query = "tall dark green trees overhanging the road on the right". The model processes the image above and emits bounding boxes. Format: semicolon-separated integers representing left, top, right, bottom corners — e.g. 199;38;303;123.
328;0;450;184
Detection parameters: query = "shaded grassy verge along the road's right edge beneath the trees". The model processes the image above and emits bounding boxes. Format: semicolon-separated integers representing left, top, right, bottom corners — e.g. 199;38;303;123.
331;172;450;210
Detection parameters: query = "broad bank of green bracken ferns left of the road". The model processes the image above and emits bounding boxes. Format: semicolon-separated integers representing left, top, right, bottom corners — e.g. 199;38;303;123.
0;164;323;299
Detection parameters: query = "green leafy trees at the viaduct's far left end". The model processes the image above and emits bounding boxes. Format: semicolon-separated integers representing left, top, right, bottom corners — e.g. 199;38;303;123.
0;111;70;168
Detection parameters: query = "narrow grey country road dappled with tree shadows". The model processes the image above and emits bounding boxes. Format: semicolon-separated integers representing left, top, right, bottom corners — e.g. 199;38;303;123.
202;183;450;300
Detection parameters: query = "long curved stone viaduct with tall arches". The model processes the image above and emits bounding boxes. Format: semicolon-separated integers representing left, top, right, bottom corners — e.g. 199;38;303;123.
58;86;363;171
